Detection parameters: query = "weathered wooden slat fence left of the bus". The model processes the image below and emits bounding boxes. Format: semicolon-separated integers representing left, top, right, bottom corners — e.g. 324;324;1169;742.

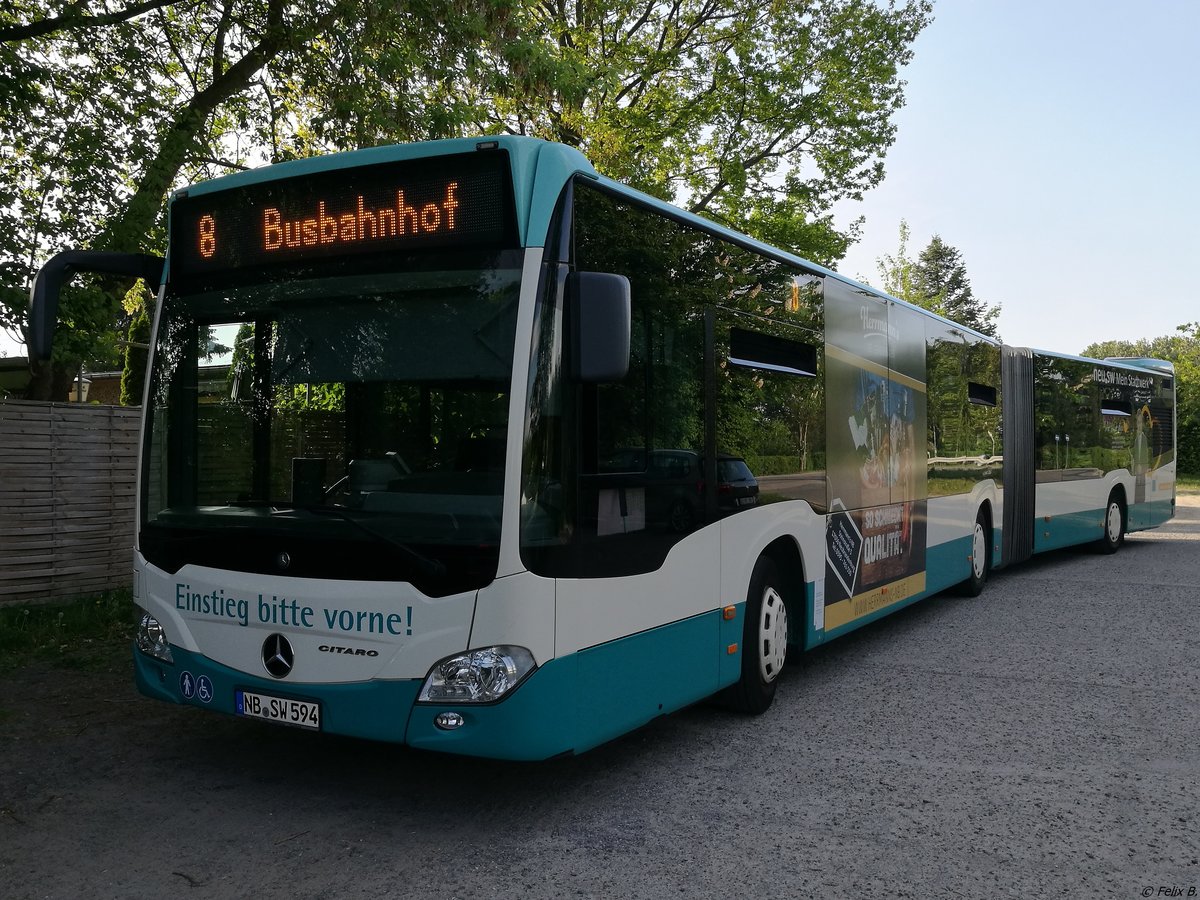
0;400;142;606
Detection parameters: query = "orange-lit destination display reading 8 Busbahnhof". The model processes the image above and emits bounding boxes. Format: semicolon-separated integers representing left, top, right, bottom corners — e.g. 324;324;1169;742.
170;151;515;281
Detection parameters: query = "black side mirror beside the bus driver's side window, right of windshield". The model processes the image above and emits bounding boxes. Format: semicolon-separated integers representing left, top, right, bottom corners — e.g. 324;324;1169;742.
566;272;631;384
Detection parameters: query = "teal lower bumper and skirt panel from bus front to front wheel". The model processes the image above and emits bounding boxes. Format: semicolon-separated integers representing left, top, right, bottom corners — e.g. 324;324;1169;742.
133;605;729;760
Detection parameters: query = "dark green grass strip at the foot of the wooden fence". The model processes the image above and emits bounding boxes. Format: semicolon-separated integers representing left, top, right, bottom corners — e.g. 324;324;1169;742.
0;590;133;672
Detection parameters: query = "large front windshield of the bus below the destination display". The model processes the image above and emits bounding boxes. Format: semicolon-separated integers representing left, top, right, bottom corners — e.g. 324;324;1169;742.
140;252;520;593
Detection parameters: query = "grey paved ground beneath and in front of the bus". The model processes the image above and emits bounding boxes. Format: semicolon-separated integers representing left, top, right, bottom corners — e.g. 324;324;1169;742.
0;498;1200;900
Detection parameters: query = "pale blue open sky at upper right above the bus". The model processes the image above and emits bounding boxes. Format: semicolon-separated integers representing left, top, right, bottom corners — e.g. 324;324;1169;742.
835;0;1200;353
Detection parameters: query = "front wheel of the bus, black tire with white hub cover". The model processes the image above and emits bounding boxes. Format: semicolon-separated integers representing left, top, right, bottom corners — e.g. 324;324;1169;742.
728;557;787;715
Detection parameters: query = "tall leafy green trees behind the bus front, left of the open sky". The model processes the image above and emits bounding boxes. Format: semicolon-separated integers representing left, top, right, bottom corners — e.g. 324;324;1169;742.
0;0;931;396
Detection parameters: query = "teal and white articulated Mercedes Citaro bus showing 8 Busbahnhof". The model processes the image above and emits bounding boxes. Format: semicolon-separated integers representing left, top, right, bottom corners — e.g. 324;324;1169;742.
34;137;1175;760
